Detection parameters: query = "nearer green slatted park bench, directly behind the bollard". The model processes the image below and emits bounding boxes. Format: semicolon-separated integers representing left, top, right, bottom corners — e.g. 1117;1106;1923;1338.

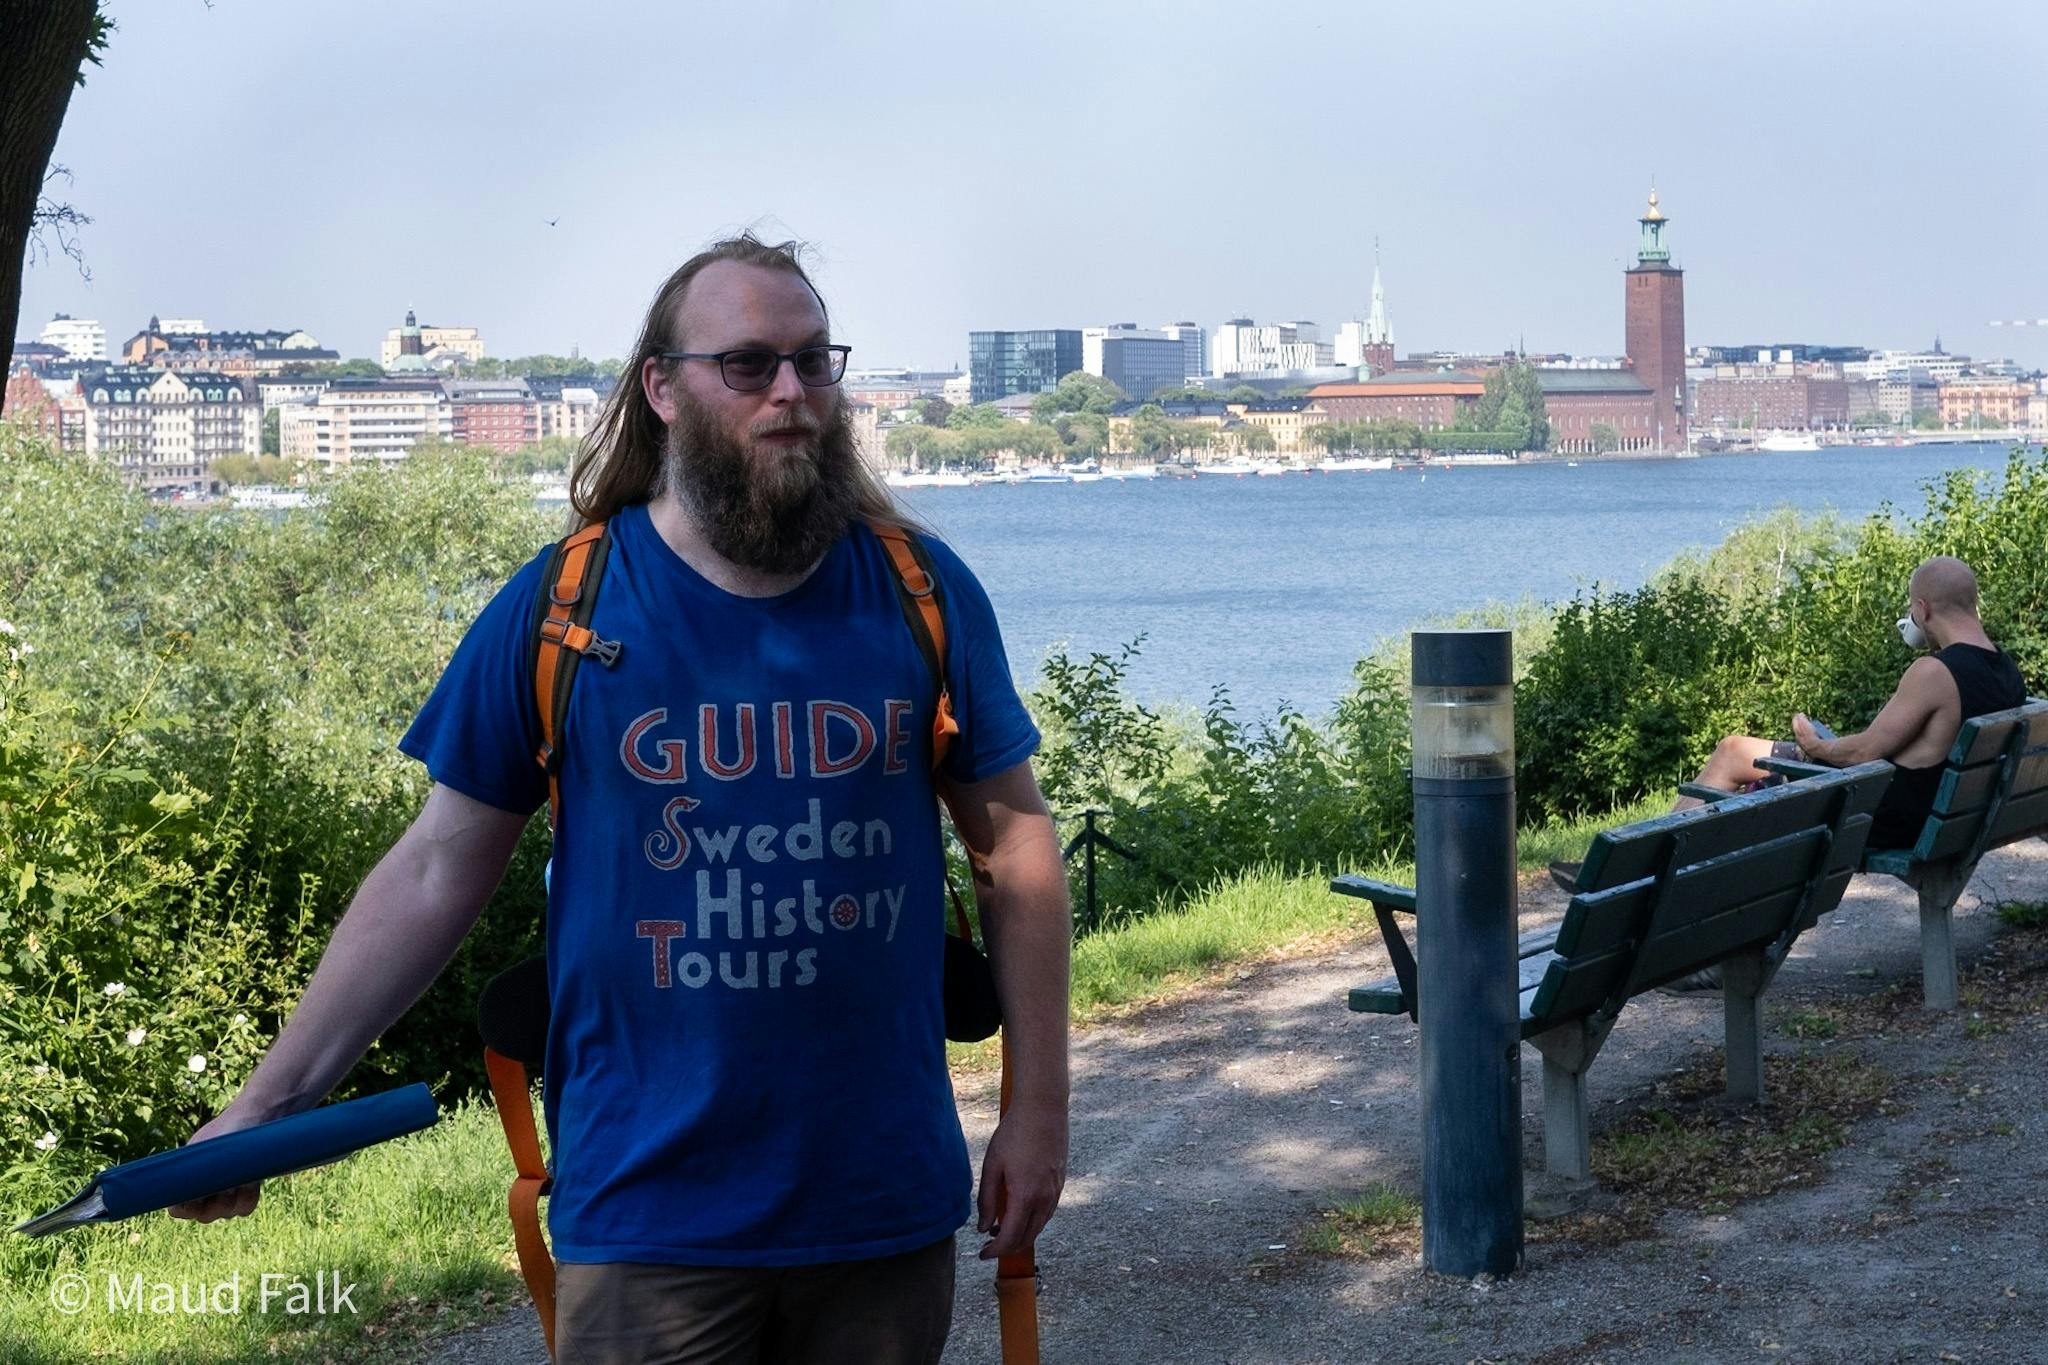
1331;763;1892;1181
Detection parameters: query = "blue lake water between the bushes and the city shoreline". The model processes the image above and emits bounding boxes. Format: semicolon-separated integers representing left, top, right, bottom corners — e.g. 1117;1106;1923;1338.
899;444;2007;716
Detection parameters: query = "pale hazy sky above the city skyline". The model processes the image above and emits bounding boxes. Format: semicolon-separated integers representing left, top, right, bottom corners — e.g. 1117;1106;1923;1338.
20;0;2048;368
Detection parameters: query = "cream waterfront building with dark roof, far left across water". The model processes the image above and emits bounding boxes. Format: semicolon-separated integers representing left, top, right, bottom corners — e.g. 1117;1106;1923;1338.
80;366;262;489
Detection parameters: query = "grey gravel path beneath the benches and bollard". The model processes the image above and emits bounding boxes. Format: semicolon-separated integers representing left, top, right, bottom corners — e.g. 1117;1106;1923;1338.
422;841;2048;1365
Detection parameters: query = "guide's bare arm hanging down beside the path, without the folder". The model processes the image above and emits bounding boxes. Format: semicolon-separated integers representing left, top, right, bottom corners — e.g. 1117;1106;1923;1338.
950;761;1073;1261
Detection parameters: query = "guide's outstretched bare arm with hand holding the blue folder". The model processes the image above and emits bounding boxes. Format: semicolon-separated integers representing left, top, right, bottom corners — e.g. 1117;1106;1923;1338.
170;786;528;1222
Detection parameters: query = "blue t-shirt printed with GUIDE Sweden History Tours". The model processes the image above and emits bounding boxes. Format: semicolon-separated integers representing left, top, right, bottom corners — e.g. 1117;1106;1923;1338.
399;503;1038;1265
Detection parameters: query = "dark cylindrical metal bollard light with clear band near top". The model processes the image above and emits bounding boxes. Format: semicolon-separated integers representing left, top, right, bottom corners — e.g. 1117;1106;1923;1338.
1411;630;1522;1277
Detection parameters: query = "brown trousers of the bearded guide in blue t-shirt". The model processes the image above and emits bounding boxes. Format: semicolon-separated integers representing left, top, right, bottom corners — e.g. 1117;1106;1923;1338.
555;1236;954;1365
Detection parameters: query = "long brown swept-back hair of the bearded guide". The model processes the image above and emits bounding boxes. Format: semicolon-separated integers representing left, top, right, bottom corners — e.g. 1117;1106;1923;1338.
569;231;915;530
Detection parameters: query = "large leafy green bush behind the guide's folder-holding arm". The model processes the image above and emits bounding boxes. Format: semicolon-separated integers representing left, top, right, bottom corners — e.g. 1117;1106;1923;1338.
0;428;555;1211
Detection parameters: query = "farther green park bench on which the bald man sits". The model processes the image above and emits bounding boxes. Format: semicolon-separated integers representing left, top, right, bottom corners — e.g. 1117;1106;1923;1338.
1736;698;2048;1009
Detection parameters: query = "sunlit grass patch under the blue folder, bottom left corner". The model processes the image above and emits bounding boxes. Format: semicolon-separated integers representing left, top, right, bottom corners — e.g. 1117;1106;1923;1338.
0;1103;530;1365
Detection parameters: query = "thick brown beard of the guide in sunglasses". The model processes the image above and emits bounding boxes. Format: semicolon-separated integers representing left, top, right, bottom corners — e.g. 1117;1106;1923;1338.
664;401;860;573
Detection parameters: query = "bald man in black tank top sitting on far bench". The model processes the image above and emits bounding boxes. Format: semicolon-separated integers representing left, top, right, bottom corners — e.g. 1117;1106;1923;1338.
1550;555;2028;988
